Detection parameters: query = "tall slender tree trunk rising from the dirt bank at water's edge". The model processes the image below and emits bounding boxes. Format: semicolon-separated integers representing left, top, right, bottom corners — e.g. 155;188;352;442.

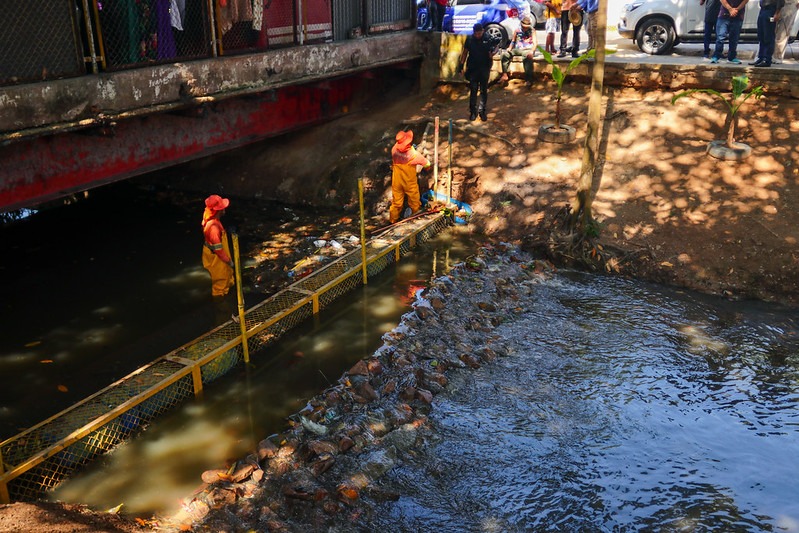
569;0;608;233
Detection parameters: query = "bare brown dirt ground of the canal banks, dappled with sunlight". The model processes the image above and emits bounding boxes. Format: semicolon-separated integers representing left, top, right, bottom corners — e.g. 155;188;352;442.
0;68;799;533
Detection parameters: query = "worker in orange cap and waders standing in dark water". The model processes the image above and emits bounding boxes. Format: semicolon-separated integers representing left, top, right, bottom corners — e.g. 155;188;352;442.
202;194;234;323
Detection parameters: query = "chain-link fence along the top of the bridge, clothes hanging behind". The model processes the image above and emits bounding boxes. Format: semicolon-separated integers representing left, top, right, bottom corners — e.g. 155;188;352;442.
0;0;413;86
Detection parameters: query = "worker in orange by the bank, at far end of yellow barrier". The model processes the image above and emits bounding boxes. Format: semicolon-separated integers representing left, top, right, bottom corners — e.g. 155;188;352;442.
389;131;430;224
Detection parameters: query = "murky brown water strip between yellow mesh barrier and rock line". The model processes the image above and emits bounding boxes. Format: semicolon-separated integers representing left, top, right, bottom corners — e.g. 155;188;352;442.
51;228;473;516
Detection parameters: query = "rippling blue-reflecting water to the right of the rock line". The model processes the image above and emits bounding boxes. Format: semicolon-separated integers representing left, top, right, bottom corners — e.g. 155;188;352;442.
366;274;799;532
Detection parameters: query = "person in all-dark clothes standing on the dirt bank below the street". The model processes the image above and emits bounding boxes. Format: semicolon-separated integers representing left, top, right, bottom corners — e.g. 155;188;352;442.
458;22;499;121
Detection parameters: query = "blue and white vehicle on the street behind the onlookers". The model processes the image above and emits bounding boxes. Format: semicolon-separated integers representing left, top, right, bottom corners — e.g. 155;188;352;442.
417;0;544;47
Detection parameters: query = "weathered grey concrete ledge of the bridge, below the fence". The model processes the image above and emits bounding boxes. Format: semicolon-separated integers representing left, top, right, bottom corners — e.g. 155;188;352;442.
0;30;422;142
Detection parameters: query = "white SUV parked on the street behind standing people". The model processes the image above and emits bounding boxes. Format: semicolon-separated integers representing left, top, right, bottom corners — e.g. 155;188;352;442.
618;0;799;55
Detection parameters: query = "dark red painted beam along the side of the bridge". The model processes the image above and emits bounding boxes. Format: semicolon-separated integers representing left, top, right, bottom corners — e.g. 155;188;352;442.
0;76;365;211
